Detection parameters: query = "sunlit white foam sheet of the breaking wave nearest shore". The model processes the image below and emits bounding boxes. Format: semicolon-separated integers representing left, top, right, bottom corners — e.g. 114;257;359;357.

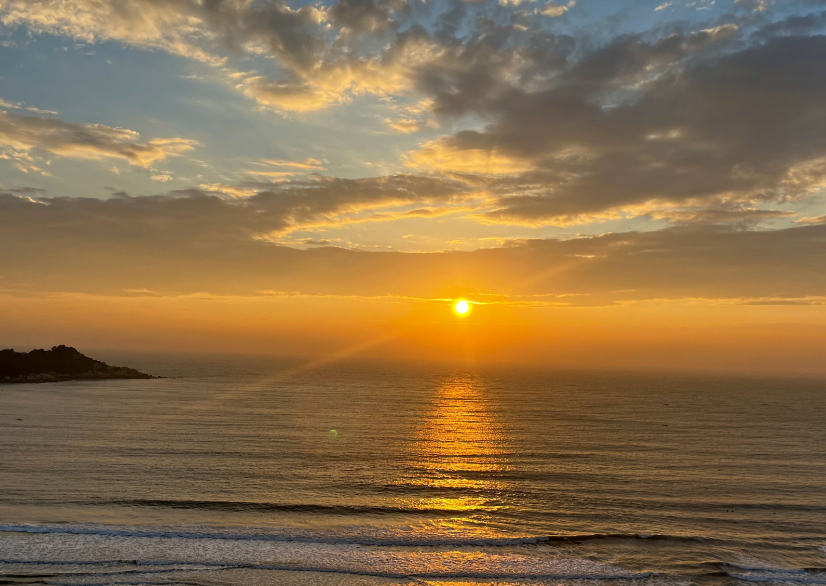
0;528;646;579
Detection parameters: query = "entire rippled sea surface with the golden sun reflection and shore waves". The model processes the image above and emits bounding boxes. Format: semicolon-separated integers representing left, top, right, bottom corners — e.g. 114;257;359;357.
0;353;826;586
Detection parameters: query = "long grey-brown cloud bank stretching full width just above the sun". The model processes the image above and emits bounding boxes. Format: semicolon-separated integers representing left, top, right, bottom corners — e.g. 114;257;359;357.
0;188;826;305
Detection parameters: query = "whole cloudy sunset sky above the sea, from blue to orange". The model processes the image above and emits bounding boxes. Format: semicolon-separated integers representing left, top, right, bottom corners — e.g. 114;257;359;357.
0;0;826;372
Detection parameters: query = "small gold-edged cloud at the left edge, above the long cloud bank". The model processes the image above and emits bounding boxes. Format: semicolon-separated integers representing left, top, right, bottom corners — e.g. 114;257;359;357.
0;112;198;167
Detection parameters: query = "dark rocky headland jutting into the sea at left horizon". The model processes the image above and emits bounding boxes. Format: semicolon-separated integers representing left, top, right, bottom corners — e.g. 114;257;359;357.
0;345;163;384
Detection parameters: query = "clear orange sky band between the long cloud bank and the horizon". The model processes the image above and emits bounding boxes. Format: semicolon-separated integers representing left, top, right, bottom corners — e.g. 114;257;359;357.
0;286;826;372
